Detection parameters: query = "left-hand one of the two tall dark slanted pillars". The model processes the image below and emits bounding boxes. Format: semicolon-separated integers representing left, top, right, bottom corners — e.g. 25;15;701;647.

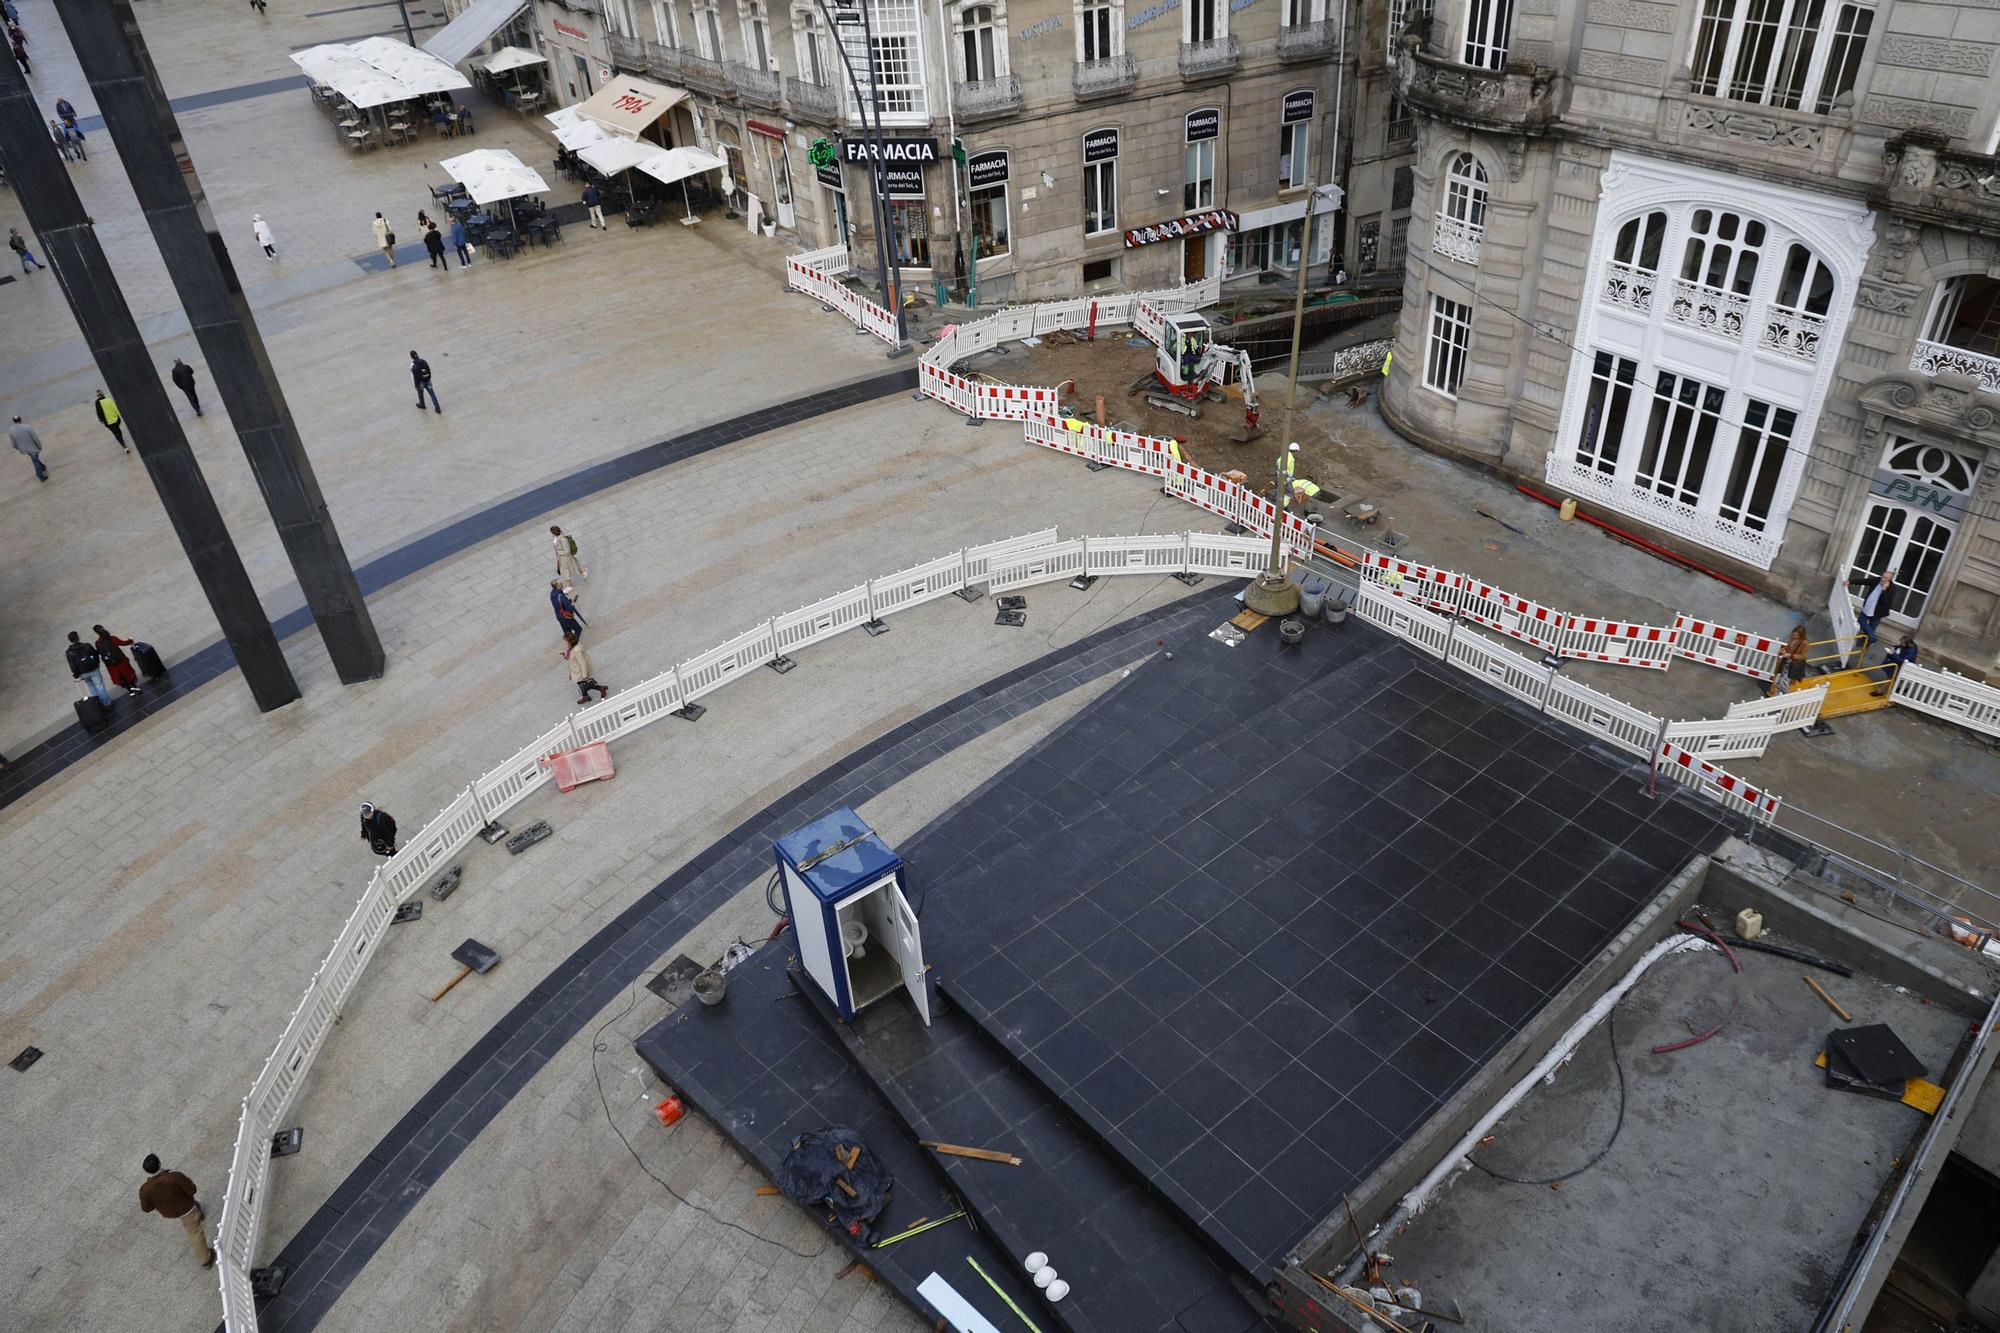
0;45;298;713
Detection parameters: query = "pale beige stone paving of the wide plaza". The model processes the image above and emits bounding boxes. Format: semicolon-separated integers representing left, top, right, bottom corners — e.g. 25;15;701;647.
0;0;2000;1333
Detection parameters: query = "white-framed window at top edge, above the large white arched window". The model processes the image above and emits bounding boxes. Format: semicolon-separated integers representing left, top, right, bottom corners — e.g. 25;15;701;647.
1690;0;1874;114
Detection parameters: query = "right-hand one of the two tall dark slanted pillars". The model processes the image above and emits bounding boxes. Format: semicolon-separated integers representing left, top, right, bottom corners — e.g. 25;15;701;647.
62;0;382;685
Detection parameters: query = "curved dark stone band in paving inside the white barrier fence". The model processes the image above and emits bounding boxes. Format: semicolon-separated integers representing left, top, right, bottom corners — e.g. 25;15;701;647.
230;582;1234;1333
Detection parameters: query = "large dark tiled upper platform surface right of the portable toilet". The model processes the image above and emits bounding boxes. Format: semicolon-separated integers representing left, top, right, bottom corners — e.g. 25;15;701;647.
928;624;1728;1281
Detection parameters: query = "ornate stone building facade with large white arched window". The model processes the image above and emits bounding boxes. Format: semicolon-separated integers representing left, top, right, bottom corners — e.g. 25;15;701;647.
1354;0;2000;675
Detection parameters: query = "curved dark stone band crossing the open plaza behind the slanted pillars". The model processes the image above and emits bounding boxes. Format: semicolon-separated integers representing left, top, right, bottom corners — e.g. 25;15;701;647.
0;366;916;811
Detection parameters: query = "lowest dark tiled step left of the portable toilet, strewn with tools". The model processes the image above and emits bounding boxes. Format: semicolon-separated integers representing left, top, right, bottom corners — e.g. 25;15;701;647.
636;956;1050;1329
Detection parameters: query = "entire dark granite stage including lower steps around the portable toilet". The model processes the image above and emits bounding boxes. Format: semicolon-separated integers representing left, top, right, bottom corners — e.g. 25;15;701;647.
638;598;1730;1333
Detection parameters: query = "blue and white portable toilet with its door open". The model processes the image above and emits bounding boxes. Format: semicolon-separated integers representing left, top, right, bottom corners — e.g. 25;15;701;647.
774;807;930;1027
